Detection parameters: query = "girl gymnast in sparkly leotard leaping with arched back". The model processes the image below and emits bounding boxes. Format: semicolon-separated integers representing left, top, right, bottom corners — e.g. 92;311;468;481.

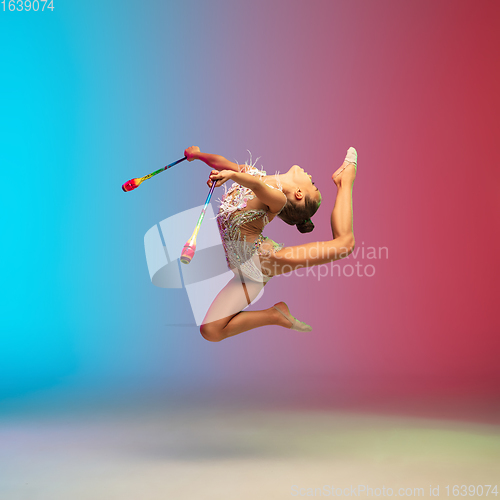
184;146;357;342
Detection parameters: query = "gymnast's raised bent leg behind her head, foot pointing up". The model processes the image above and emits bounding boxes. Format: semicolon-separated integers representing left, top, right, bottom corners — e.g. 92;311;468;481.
261;154;356;276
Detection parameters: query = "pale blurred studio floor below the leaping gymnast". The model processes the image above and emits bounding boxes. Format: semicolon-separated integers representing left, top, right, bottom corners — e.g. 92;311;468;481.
0;407;500;500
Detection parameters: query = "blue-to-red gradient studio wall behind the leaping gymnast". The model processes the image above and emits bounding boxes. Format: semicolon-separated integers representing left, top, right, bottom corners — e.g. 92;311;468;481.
0;1;500;408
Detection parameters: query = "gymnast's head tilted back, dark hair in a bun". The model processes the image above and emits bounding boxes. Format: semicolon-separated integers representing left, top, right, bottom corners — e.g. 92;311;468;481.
278;165;321;233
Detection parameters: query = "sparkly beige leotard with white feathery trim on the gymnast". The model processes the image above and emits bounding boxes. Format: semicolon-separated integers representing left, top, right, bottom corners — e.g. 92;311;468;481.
216;160;286;282
